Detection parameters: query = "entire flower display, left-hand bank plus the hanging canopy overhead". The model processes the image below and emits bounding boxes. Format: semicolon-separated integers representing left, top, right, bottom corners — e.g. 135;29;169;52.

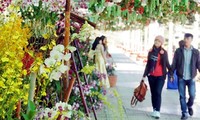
0;0;200;120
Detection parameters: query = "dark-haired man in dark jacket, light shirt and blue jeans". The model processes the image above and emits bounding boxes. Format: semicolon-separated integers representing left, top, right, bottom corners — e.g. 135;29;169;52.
171;33;200;120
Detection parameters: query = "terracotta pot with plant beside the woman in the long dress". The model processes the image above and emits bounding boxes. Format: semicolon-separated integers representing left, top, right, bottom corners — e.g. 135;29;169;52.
106;63;117;87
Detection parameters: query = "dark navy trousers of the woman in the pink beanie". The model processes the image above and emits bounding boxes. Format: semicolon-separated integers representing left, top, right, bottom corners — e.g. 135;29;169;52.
148;76;165;111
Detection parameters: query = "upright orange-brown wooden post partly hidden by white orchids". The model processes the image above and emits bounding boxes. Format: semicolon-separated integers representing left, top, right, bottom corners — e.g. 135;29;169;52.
63;0;70;102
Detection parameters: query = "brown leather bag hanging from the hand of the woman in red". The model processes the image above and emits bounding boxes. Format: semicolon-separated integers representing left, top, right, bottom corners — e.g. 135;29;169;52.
131;80;147;107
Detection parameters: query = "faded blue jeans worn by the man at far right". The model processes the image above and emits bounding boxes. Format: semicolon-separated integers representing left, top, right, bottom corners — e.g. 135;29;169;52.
178;79;196;114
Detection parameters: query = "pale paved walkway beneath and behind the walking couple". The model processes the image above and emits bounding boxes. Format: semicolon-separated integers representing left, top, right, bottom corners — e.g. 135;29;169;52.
91;47;200;120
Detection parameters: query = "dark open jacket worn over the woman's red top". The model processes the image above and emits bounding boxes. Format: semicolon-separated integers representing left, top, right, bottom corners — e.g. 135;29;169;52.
143;48;171;78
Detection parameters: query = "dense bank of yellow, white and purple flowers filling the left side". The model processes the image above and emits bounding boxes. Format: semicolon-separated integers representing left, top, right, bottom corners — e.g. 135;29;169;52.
0;0;122;120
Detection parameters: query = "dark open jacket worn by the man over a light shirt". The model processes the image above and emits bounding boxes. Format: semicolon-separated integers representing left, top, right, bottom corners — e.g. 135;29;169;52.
171;47;200;79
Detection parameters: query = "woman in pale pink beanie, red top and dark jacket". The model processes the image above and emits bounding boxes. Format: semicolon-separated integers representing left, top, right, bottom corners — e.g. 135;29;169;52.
143;35;170;119
